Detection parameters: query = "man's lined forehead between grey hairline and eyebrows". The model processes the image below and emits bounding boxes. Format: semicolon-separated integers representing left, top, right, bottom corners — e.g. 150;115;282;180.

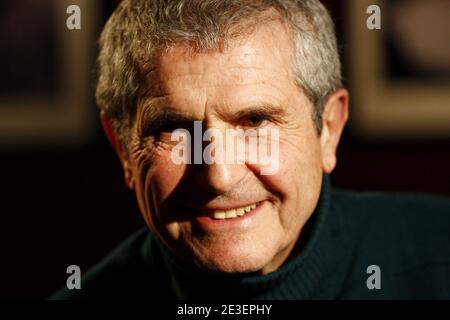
142;21;297;114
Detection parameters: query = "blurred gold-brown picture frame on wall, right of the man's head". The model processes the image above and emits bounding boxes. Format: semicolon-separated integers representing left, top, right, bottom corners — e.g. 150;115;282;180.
346;0;450;139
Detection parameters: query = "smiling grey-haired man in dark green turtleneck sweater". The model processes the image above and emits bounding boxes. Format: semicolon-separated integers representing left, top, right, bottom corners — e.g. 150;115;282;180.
54;0;450;299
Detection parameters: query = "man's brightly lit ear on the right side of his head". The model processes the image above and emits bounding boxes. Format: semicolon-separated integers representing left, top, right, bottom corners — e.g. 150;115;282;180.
320;89;349;173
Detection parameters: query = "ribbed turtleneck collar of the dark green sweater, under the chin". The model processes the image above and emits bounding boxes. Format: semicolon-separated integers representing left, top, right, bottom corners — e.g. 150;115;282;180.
148;175;348;300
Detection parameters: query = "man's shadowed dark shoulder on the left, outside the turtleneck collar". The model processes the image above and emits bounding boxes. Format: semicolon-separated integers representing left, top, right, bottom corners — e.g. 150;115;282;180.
50;228;170;300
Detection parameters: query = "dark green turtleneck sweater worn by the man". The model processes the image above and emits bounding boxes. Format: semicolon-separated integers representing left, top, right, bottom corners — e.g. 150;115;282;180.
52;177;450;301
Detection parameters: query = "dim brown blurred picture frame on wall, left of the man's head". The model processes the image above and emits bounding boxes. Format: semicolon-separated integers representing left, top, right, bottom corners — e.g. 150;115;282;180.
0;0;97;148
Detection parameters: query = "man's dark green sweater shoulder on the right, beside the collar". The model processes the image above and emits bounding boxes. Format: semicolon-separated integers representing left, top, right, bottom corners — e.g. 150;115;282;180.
332;190;450;298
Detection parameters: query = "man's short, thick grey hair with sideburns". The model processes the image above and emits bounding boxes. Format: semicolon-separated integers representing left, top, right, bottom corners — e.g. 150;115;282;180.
96;0;342;143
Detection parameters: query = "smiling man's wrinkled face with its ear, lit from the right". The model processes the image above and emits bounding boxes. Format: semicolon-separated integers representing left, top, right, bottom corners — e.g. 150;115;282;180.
107;22;347;274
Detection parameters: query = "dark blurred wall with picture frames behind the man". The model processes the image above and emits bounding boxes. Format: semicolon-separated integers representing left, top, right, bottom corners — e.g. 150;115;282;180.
0;0;450;299
